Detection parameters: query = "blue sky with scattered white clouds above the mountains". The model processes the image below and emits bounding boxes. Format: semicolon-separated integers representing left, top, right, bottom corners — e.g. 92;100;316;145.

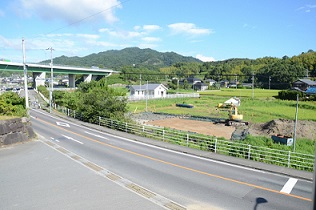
0;0;316;62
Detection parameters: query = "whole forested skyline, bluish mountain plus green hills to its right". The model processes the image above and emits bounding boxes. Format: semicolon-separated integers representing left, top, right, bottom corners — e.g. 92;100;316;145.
45;47;316;89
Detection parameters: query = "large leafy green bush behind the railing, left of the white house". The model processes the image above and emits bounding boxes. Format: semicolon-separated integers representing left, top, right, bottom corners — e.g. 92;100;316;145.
46;78;127;123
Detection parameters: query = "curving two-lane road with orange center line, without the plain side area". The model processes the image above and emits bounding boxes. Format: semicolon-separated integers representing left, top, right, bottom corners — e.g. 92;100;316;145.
15;111;312;210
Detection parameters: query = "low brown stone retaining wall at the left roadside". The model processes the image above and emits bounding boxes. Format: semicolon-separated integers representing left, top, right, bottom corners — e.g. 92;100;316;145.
0;118;36;146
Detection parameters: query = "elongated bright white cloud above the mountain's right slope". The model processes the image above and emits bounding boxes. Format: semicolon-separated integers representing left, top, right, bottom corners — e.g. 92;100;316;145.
168;23;213;35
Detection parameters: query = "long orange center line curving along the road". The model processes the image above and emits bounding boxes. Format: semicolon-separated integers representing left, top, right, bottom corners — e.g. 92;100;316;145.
36;118;312;201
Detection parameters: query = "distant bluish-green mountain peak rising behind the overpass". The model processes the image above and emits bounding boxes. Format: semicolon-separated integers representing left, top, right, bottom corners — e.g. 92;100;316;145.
42;47;202;70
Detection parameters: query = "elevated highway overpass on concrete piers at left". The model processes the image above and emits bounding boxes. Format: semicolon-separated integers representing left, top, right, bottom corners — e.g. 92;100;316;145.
0;61;117;88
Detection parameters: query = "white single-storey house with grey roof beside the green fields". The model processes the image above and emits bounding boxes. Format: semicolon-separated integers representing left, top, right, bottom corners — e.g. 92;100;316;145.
130;84;168;98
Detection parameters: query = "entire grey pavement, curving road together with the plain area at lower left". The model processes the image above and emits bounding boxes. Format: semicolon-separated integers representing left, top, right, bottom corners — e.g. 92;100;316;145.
0;89;312;210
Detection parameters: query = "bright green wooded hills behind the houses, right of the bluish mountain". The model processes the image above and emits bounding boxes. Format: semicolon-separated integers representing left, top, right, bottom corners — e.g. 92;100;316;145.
121;50;316;89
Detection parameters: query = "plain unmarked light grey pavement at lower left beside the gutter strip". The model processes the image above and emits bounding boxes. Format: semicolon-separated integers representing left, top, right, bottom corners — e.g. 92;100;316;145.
0;141;163;210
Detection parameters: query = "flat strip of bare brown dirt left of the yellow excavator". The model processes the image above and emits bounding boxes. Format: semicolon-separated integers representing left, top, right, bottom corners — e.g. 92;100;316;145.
146;118;235;139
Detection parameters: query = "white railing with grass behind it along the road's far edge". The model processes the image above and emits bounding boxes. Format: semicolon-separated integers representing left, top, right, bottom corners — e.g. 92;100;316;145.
56;106;315;171
